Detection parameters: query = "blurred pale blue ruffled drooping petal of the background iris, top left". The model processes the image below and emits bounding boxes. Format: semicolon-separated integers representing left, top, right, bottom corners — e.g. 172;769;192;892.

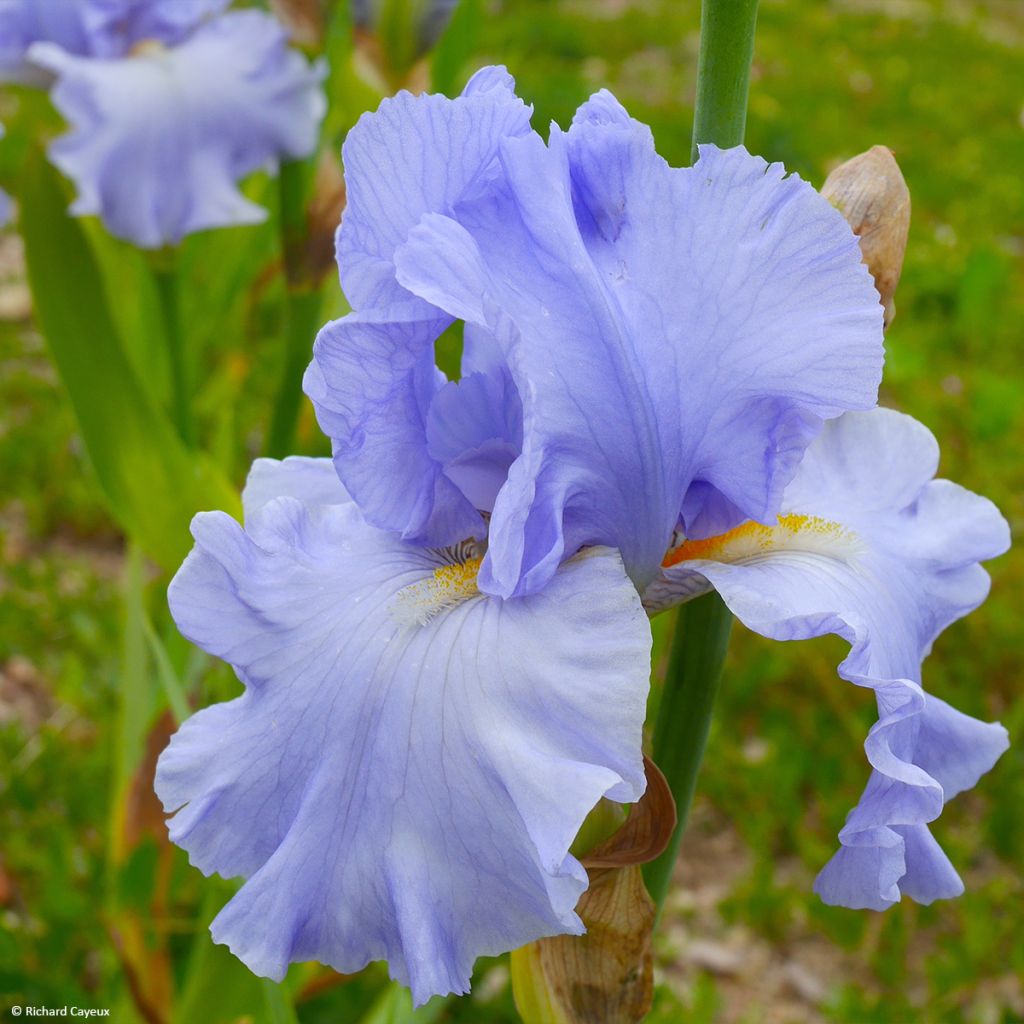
30;11;325;249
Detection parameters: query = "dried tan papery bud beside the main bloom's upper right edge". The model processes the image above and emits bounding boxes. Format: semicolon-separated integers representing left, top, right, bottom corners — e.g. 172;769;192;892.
821;145;910;327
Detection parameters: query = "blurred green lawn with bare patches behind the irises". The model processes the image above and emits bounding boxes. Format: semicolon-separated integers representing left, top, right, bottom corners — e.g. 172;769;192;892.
0;0;1024;1024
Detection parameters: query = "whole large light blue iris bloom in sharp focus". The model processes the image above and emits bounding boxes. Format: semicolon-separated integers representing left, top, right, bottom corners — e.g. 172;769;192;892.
157;69;1007;1002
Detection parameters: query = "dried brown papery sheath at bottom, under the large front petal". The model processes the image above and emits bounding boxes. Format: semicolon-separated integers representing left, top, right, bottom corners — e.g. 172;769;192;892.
512;758;676;1024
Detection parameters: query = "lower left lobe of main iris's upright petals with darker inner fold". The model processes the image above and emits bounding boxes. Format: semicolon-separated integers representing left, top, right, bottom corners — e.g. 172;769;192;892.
303;303;522;545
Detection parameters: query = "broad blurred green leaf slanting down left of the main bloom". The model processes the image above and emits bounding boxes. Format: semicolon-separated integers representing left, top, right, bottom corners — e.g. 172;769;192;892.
20;151;239;569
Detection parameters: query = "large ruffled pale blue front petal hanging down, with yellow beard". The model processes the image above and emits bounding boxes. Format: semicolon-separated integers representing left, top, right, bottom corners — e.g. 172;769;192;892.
157;464;650;1002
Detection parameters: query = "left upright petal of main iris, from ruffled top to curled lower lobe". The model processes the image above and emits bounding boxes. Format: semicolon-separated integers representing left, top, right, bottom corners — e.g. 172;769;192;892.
305;68;530;544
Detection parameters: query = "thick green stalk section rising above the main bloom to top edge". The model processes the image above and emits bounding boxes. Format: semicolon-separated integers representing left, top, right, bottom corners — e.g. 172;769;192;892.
692;0;758;161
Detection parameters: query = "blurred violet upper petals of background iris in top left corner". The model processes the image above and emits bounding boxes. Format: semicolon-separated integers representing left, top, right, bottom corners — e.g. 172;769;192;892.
0;0;230;84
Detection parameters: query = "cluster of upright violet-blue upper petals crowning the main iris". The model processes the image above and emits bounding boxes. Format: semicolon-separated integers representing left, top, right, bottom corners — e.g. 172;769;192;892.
307;69;882;596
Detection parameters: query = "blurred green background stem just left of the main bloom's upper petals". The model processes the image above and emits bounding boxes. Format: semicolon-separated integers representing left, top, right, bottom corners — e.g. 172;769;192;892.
266;155;321;459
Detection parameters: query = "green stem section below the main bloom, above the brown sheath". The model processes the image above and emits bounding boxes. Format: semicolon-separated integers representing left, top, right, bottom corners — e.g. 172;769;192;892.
644;594;732;909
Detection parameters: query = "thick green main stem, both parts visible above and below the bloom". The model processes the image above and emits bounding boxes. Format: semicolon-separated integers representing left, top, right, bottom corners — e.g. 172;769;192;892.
644;0;758;909
